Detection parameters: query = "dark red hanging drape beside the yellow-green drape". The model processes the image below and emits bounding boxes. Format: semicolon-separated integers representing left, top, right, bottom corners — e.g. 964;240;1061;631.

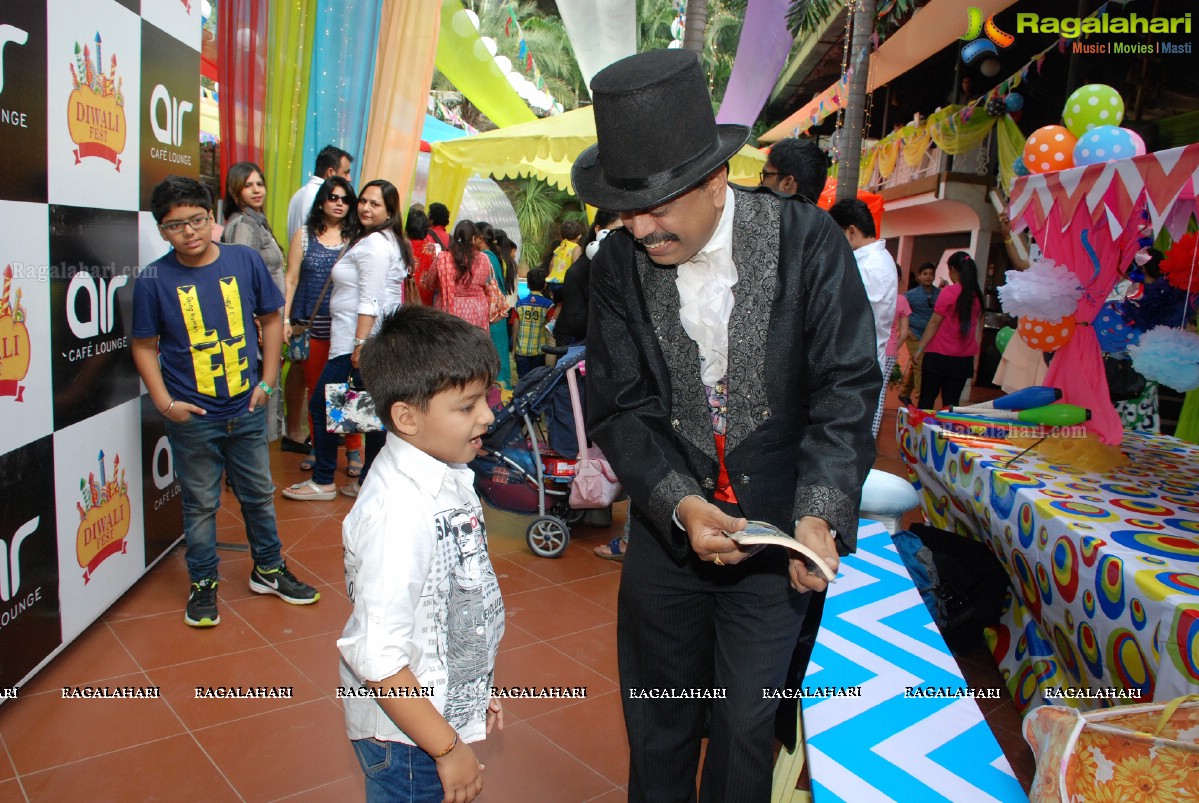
217;0;266;191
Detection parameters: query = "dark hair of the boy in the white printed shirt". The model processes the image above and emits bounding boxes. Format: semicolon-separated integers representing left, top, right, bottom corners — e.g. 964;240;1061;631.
359;304;500;434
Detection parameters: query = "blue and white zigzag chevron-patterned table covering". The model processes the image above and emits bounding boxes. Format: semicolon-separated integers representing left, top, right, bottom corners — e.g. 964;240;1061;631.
803;520;1029;803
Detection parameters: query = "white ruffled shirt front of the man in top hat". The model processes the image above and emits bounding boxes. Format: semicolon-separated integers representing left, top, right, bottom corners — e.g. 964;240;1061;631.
675;187;737;387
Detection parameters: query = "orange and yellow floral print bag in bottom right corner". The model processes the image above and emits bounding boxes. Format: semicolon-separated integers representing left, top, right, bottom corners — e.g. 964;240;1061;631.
1024;695;1199;803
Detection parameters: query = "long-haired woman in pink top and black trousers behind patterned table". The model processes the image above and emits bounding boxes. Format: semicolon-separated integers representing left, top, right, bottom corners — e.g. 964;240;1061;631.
916;250;982;410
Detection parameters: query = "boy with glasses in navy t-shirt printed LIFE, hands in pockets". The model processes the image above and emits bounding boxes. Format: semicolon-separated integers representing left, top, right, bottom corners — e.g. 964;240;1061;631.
133;176;320;627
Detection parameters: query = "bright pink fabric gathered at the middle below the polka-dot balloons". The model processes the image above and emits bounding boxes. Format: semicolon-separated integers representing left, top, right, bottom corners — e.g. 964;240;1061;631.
1035;198;1145;445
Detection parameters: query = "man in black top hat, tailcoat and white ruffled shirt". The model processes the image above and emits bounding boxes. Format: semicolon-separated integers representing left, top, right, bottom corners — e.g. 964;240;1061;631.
572;50;881;803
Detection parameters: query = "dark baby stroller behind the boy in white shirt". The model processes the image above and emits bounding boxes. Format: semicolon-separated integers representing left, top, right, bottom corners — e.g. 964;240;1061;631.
470;345;597;557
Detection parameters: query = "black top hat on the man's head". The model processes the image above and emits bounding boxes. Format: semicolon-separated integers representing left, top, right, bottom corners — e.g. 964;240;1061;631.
571;50;749;212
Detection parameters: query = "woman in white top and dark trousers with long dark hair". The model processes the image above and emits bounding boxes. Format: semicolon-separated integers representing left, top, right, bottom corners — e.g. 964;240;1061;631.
283;179;412;501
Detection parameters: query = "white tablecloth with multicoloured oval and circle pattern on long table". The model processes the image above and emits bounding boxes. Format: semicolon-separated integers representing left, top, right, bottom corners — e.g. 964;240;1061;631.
898;410;1199;710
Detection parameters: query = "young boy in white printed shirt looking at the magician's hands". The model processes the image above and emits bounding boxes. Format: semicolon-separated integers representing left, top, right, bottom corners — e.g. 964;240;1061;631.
337;306;504;803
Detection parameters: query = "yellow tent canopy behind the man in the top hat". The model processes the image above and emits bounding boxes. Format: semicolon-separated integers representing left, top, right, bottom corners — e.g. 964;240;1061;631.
428;107;766;220
